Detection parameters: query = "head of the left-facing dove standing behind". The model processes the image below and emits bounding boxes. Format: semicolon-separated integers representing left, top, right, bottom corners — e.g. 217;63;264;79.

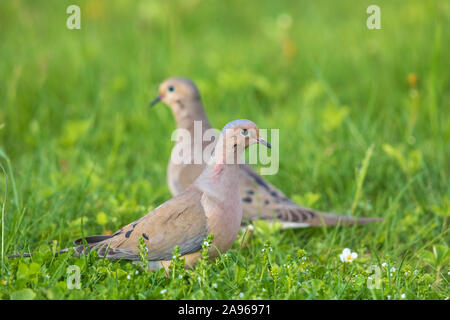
150;78;200;113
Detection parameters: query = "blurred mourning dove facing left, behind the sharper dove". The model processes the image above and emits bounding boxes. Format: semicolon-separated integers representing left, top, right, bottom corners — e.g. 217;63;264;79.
150;78;382;228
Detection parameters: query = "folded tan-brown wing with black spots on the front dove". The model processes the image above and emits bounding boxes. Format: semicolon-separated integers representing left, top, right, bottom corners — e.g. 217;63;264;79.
86;186;208;261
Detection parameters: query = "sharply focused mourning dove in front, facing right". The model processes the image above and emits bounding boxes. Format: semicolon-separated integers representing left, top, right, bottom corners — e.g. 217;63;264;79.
9;120;270;269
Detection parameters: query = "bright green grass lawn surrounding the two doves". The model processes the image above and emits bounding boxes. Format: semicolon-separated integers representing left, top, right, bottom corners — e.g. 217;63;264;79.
0;0;450;299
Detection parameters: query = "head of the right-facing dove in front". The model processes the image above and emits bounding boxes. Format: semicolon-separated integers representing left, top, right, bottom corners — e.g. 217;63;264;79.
215;119;271;164
